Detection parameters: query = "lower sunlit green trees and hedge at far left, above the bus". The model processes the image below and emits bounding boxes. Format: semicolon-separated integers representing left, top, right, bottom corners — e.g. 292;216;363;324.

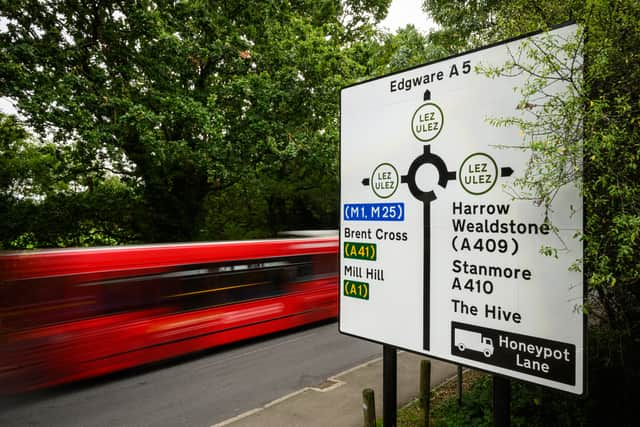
0;114;138;249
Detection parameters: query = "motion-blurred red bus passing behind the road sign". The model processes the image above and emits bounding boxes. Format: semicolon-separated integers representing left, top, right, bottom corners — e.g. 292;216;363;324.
0;237;338;394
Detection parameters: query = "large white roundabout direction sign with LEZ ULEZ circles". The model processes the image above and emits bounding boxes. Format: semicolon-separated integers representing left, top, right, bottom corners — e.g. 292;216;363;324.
340;26;584;394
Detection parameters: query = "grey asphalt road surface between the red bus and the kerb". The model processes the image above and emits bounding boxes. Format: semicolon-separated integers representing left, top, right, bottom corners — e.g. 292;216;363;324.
0;322;382;427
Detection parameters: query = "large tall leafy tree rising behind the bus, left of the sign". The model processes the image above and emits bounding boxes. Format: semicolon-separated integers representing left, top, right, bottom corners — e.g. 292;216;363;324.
0;0;389;242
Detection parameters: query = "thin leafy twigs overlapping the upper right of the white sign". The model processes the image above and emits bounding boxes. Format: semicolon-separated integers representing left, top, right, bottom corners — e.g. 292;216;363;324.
477;30;584;213
